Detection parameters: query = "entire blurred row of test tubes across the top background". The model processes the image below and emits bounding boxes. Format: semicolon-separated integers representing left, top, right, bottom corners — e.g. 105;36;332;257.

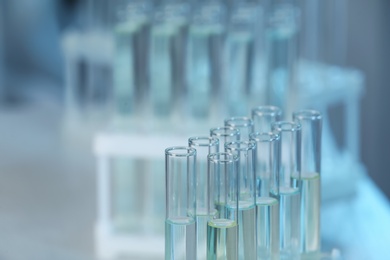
64;0;299;131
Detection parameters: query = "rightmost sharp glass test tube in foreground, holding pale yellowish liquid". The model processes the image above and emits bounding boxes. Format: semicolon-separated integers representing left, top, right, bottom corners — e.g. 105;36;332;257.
293;110;322;254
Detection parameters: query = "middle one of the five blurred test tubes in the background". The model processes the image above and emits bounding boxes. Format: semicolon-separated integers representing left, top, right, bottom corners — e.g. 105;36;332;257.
186;1;227;123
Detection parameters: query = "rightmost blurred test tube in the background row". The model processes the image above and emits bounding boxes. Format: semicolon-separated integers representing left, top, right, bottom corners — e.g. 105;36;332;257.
265;0;299;113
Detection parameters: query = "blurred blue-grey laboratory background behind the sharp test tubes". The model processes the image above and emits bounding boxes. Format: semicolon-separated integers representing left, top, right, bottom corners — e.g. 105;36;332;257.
0;0;390;260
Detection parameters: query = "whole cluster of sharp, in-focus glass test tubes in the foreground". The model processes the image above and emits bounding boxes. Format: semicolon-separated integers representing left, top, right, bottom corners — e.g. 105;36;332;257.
165;106;322;260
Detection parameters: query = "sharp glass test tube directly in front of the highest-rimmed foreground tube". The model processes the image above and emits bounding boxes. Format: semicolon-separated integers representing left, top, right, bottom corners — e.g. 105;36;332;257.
251;132;280;260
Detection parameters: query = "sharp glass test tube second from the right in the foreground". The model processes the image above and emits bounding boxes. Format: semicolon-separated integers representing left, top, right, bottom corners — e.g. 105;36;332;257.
272;121;301;259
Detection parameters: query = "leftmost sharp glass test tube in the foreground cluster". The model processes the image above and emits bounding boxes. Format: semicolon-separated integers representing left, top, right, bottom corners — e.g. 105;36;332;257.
165;147;197;260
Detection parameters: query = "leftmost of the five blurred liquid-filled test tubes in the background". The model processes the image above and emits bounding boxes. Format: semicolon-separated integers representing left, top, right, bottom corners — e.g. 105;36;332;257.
113;0;152;122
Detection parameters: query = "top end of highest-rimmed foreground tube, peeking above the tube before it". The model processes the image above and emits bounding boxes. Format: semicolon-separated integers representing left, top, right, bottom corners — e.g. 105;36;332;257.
252;106;282;133
